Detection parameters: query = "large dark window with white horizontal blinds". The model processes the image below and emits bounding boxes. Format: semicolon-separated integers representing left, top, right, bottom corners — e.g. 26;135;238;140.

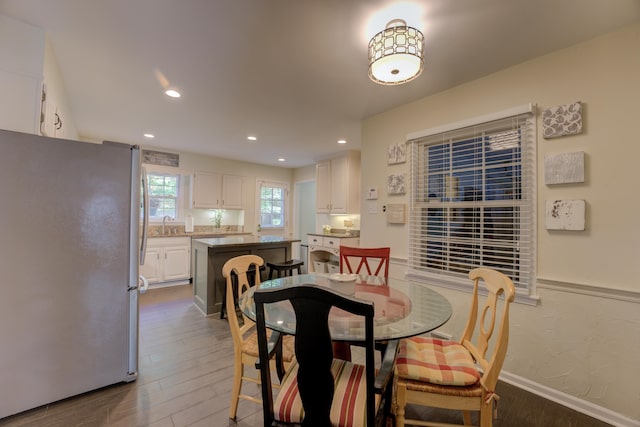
409;113;535;292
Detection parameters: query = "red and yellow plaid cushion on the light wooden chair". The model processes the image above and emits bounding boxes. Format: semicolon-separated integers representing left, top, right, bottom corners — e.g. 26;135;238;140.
396;337;480;386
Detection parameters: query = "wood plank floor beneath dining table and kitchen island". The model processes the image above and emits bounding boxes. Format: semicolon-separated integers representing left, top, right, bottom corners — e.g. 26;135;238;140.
0;285;608;427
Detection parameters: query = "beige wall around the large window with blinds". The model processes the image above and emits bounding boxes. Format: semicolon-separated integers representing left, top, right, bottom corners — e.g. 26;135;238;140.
361;25;640;421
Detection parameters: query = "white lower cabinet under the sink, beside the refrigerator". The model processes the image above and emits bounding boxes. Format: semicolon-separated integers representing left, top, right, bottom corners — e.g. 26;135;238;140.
140;237;191;284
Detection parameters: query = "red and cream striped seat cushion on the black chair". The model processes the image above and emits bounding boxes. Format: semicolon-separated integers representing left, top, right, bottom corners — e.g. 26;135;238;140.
274;359;380;427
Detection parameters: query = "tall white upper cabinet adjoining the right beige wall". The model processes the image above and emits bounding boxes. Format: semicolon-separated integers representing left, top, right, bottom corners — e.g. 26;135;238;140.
316;151;360;214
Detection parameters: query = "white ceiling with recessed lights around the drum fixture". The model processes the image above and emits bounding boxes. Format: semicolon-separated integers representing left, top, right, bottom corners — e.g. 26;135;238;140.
0;0;640;167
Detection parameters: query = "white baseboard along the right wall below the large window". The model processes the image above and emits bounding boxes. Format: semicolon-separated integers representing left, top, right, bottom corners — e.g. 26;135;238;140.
500;370;640;427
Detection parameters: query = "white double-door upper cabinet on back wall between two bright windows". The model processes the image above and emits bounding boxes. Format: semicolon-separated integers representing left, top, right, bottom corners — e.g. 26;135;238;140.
191;172;243;209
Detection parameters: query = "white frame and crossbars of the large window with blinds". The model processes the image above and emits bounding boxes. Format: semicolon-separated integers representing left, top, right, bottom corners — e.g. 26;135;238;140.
406;104;538;305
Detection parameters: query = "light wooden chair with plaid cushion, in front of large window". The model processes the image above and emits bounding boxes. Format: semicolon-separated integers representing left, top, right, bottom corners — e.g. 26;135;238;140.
395;268;515;427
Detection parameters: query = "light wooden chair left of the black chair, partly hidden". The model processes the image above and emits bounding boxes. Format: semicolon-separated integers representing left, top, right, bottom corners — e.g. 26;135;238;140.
222;255;294;419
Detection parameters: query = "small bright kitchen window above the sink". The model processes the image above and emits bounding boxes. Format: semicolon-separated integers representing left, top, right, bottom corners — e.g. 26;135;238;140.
147;171;180;221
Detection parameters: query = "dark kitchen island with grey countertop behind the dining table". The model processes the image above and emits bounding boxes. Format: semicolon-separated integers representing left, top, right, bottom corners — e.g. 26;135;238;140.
191;235;300;316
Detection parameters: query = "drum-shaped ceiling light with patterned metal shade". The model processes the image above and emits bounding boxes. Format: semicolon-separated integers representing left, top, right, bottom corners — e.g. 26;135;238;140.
369;19;424;85
